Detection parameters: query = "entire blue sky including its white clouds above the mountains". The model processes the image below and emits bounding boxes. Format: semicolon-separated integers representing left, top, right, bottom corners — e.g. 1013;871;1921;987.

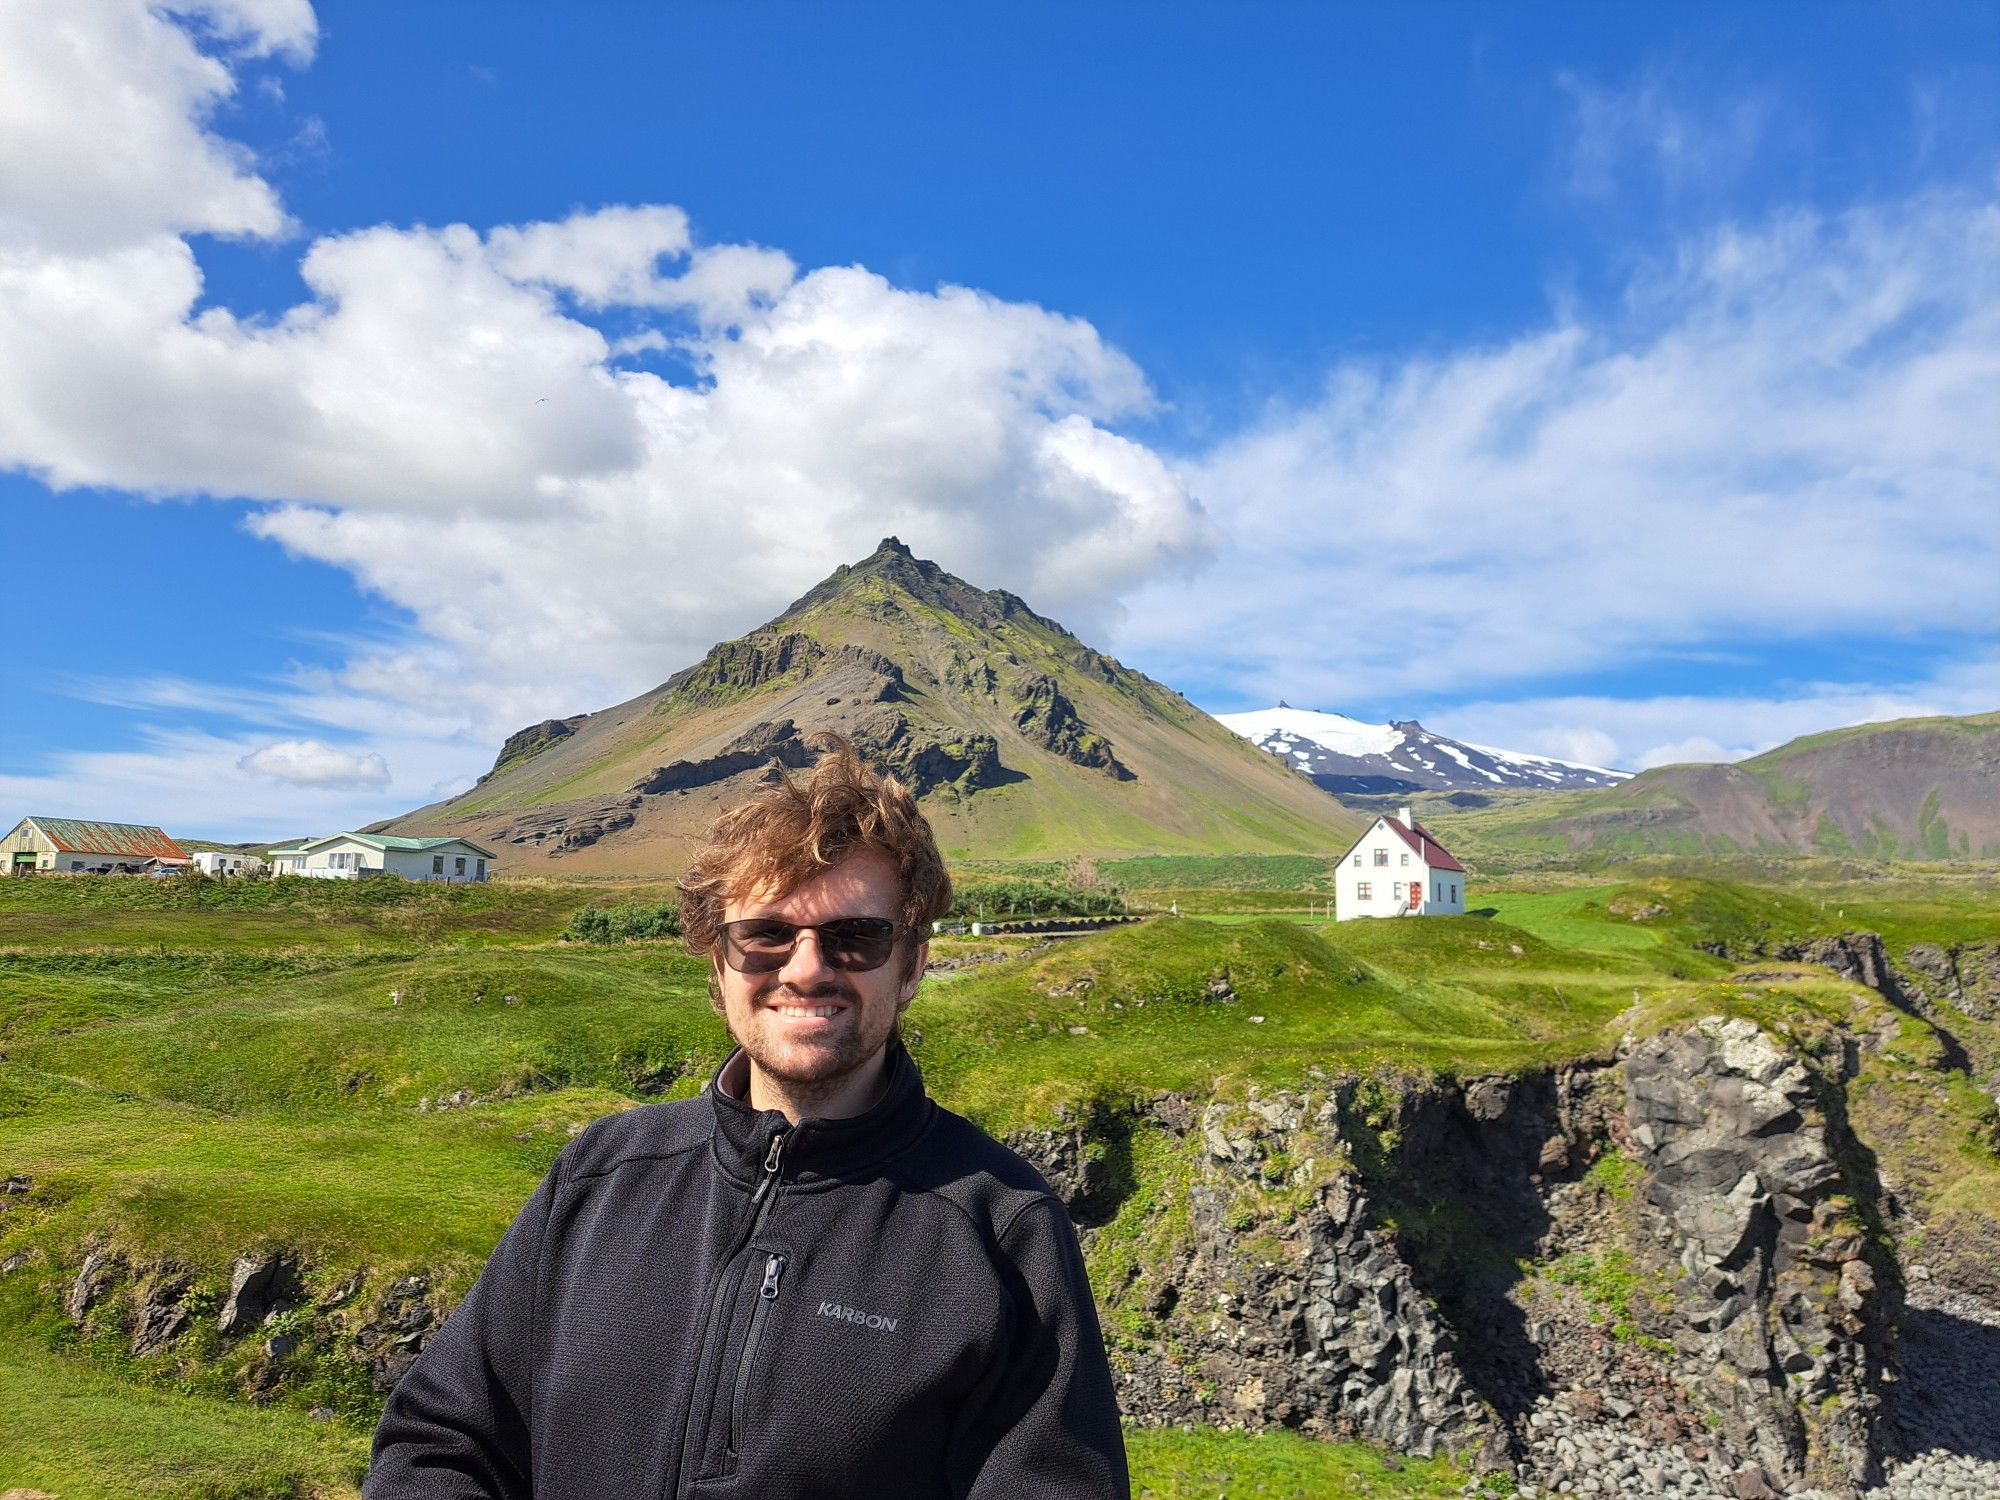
0;0;2000;838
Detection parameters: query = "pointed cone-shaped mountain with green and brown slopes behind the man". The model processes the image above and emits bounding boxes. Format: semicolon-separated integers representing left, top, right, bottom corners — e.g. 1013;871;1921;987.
382;538;1360;874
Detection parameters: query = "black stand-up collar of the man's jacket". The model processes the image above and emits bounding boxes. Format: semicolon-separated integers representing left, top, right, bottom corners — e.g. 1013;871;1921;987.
708;1038;932;1184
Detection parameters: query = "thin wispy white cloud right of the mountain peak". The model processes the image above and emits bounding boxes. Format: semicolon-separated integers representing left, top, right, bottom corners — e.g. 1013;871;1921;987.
1130;192;2000;716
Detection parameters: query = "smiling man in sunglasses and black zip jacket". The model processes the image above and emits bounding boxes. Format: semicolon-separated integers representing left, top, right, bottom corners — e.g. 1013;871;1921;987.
366;744;1128;1500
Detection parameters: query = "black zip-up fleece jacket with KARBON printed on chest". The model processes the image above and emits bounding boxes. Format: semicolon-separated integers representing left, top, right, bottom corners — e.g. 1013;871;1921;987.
364;1042;1128;1500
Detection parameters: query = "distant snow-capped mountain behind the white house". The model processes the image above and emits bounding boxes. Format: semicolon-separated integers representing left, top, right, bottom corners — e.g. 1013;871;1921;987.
1216;700;1632;796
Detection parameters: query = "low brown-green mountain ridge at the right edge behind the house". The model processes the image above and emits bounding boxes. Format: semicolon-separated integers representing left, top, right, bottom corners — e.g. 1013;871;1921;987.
1466;714;2000;860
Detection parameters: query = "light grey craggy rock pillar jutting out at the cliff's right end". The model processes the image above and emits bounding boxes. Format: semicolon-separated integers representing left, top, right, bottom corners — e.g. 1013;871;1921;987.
1626;1018;1900;1490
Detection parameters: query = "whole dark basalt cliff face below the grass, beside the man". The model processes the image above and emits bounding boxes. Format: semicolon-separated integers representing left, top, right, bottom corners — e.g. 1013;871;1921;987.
1014;1016;1936;1496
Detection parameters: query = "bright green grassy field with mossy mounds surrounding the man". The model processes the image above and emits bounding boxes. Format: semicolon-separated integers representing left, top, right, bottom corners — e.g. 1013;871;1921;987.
0;856;2000;1500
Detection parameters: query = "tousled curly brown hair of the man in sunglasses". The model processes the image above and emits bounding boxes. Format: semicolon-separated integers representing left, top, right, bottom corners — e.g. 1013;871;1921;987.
678;734;952;992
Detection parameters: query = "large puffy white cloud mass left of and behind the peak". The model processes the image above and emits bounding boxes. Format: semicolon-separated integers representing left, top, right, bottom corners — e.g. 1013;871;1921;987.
0;0;1214;776
